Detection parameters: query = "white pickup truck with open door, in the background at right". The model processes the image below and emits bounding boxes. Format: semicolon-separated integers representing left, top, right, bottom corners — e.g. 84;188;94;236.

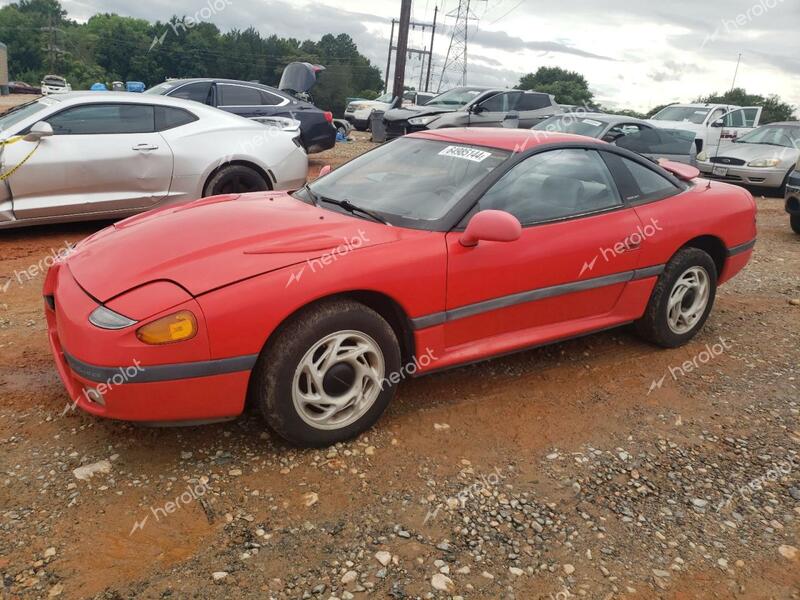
649;104;764;152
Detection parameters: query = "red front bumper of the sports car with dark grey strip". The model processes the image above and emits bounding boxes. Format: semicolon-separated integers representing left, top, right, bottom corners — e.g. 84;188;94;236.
44;263;257;423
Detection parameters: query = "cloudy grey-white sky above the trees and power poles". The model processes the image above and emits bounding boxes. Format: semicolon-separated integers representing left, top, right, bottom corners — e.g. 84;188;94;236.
15;0;800;110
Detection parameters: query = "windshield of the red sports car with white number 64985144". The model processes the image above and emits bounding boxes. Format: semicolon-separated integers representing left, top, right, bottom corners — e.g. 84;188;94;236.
295;137;509;229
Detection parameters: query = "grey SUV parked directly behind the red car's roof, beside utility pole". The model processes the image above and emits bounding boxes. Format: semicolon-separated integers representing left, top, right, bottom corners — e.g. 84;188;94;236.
383;87;563;140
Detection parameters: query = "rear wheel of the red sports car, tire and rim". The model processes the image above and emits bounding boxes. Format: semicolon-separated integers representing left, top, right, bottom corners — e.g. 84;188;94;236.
635;248;717;348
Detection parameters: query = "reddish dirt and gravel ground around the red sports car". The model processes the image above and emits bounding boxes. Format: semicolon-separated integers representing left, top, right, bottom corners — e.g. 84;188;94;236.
0;129;800;600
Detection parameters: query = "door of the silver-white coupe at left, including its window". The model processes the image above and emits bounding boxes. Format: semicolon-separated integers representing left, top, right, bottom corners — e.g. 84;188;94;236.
6;102;173;219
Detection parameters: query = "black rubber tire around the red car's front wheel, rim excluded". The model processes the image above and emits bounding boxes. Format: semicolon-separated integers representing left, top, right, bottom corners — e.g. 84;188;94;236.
255;302;401;447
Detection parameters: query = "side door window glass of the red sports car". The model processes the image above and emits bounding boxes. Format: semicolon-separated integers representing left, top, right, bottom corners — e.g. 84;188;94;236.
478;149;622;226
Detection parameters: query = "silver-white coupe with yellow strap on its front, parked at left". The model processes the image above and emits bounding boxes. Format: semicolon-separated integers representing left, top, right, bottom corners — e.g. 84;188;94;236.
0;92;308;229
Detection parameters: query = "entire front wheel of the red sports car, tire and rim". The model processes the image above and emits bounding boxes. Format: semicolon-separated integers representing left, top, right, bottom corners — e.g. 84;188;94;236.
251;300;402;448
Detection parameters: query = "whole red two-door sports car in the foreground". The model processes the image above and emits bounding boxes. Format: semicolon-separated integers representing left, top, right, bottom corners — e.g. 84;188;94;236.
44;129;756;446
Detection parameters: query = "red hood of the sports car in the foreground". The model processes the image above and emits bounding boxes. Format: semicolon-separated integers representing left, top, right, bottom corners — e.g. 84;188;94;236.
67;192;406;302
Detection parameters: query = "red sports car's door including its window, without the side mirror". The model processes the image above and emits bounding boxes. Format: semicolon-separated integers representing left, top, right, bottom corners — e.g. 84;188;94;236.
445;148;640;348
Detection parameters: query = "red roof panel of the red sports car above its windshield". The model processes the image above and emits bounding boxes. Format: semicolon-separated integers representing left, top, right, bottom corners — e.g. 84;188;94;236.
407;127;604;152
